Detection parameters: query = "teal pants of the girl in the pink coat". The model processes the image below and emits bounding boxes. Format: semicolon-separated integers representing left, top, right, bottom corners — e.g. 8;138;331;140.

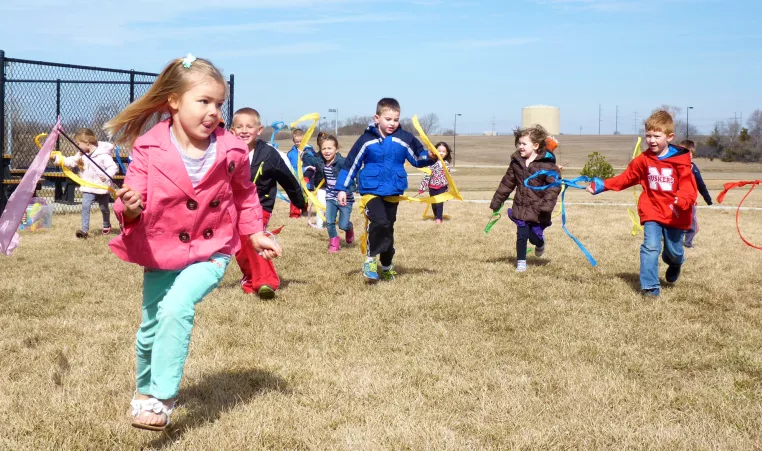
135;254;230;399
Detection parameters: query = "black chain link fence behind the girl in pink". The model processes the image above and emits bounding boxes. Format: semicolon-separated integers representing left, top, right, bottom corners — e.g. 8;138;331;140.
0;50;234;213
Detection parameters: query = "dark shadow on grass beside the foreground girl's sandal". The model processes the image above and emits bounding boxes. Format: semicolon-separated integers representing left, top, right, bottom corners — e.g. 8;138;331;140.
149;369;290;448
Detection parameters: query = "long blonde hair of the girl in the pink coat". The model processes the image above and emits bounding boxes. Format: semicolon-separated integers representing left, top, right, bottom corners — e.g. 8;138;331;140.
103;58;228;148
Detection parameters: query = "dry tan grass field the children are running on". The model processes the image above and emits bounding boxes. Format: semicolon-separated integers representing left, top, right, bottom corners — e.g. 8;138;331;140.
0;147;762;450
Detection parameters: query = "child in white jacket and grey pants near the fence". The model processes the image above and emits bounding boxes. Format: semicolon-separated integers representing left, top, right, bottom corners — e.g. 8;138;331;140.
54;128;118;239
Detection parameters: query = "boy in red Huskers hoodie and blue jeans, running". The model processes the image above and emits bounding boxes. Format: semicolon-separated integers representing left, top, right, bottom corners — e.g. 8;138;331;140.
587;111;698;296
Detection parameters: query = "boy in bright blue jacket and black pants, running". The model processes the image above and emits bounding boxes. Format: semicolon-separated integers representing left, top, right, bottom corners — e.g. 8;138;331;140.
336;98;437;283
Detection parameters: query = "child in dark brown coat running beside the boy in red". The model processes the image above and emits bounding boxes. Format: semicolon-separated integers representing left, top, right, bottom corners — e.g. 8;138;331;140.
489;125;561;272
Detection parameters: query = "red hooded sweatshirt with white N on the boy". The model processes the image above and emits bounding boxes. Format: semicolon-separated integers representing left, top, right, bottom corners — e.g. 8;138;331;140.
593;145;698;230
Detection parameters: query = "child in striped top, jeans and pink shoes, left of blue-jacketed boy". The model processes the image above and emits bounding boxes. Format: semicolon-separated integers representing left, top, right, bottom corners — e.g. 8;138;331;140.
314;135;355;253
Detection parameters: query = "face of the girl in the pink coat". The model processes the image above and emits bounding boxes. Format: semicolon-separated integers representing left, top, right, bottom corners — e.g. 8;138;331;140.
168;76;225;142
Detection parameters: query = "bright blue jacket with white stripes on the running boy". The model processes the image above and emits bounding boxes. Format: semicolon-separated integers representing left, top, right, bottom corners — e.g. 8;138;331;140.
336;125;436;196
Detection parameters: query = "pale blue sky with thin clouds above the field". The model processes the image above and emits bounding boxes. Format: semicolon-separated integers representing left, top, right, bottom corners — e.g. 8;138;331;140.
0;0;762;133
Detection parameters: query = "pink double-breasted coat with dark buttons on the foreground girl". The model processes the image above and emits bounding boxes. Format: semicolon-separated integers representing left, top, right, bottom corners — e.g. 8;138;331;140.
109;119;263;270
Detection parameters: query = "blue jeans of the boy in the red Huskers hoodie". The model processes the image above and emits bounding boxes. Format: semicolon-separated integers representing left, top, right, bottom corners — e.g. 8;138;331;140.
640;221;685;290
